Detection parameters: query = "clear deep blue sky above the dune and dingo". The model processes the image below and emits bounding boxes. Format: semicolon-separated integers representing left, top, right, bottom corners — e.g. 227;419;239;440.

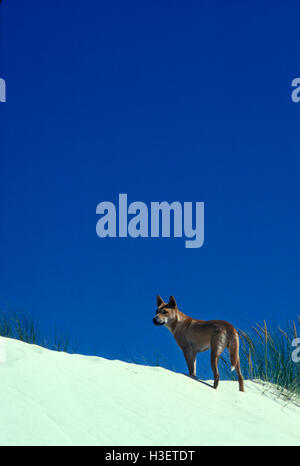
0;0;300;374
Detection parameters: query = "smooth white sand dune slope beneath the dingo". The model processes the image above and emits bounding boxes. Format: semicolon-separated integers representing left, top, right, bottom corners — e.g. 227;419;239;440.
0;338;300;446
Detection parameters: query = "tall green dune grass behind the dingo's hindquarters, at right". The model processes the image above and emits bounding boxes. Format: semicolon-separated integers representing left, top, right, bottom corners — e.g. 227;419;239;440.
221;317;300;402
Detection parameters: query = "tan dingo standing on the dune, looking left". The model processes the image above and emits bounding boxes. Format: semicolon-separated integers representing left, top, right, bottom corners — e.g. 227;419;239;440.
153;296;244;392
